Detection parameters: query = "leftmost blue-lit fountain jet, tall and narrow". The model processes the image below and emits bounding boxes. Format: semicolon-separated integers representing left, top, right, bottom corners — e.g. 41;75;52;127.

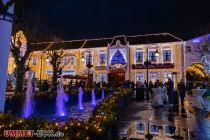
22;70;34;118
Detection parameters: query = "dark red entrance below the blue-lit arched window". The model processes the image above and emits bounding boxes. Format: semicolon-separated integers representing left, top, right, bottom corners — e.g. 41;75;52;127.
108;72;125;87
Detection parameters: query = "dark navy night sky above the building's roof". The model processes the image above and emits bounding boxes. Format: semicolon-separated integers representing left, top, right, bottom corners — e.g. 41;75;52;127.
27;0;210;40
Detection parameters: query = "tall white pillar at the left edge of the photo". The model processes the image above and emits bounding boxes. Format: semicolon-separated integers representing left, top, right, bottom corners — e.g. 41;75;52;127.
0;0;14;112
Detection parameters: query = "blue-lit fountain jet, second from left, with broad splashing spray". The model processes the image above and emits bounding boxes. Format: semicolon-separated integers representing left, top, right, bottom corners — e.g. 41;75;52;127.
56;76;68;116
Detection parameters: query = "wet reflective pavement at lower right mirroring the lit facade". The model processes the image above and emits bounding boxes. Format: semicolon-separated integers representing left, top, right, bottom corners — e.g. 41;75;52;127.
118;96;210;140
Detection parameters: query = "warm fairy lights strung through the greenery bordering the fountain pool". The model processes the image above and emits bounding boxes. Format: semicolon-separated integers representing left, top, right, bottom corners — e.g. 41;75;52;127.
0;88;131;140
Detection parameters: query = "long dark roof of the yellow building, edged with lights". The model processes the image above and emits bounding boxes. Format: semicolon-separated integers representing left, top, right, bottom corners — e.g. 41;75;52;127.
32;33;183;51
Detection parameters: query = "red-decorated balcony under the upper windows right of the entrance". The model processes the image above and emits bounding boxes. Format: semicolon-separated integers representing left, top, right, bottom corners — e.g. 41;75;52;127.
132;63;174;69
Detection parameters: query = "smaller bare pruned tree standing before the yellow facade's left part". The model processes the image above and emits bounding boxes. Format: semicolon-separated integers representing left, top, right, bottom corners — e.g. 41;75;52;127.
47;49;68;85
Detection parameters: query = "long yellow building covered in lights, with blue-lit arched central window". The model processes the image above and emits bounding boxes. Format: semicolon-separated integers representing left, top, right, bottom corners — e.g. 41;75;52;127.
9;33;185;83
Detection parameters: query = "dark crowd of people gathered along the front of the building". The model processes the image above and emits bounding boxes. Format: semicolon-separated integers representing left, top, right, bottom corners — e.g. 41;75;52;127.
39;76;208;105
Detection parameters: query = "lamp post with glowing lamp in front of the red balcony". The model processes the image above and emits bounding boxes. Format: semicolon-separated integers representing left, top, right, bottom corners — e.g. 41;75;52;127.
144;45;159;100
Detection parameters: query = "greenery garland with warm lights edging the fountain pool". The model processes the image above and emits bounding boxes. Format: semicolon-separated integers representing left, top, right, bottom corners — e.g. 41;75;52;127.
0;88;132;140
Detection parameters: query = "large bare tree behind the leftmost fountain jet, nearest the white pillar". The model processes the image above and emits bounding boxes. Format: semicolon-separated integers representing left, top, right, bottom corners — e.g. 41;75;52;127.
10;6;47;93
